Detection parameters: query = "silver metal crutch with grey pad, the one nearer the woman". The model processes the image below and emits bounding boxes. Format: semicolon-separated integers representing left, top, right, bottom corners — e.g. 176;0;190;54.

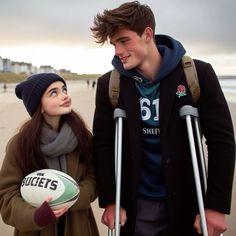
108;108;126;236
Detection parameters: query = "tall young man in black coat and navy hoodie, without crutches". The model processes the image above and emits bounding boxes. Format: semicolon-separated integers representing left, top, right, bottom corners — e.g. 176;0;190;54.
91;1;235;236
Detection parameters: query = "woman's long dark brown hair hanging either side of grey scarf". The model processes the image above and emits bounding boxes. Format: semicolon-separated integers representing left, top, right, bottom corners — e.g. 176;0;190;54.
18;108;92;175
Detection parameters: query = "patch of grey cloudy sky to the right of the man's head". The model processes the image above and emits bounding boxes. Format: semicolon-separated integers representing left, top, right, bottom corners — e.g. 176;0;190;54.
157;0;236;53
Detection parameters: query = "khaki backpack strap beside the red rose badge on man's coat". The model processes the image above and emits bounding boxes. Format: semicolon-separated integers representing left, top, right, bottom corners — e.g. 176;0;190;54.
182;55;201;104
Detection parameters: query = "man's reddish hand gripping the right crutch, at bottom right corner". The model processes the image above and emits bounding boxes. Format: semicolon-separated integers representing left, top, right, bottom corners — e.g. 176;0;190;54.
194;209;227;236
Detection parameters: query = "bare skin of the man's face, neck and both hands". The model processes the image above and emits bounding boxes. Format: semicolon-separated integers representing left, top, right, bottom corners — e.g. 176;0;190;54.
101;27;227;236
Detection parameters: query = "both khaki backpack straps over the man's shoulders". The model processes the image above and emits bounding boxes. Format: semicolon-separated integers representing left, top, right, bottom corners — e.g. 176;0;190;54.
109;55;201;107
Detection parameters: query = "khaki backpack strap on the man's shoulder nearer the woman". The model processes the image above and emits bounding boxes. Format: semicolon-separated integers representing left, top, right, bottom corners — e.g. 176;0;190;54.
109;68;120;107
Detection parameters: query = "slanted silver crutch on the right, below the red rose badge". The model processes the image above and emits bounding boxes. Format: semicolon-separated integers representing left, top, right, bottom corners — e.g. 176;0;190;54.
179;105;208;236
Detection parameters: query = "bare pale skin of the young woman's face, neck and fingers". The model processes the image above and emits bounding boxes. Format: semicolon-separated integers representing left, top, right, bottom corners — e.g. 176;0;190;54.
41;81;72;218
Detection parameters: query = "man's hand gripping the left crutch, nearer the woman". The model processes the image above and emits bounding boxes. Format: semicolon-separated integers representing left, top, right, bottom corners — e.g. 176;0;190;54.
102;204;127;229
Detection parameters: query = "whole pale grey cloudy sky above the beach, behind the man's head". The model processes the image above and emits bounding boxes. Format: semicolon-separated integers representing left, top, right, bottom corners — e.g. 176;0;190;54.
0;0;236;74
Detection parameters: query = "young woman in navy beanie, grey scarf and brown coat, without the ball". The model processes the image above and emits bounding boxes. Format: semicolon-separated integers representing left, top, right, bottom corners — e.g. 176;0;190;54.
0;73;99;236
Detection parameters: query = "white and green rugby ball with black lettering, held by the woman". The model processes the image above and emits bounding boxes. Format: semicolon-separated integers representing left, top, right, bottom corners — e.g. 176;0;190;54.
20;169;80;210
